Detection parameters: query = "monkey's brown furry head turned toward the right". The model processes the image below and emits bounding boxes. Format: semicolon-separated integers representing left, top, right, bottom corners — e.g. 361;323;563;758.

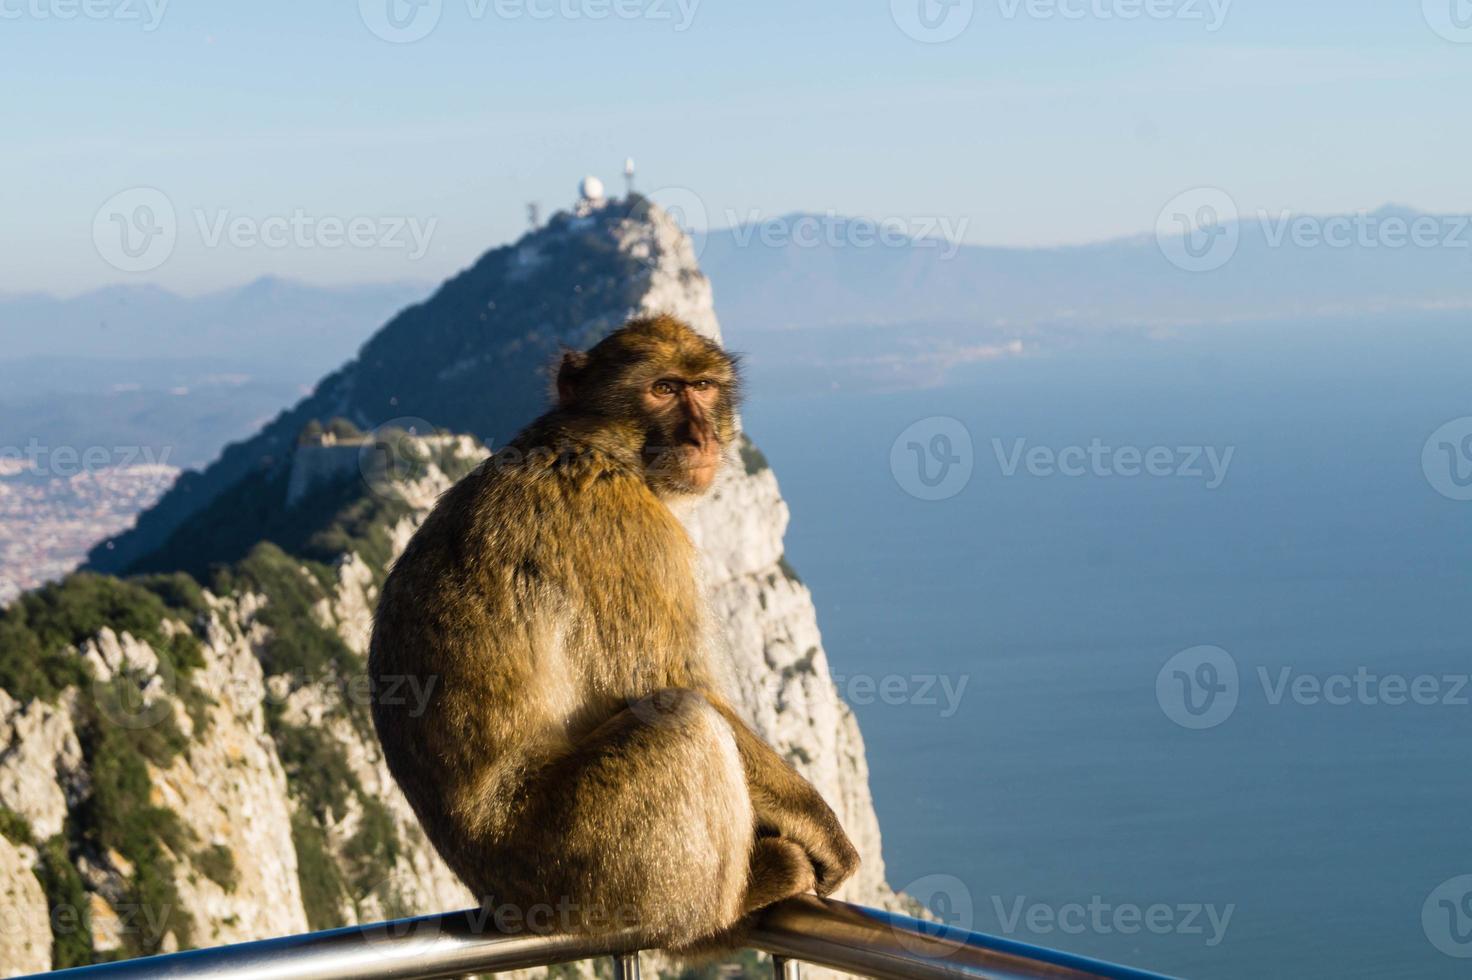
558;316;739;497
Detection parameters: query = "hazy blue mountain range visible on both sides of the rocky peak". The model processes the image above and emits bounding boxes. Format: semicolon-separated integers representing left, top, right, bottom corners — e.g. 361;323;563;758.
20;207;1472;466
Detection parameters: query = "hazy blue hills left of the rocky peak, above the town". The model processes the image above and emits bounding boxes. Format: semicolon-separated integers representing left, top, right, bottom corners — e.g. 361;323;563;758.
0;278;428;466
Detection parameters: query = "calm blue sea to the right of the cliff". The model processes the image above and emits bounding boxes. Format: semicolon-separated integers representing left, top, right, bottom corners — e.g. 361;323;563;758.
746;321;1472;977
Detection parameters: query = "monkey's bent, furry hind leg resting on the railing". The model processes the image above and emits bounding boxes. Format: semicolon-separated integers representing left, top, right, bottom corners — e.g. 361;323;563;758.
514;690;755;946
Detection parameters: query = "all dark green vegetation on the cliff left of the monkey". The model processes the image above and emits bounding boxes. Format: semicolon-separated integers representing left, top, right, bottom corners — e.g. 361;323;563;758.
0;425;478;968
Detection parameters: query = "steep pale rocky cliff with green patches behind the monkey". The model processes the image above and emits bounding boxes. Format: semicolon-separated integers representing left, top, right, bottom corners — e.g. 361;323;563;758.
0;199;894;976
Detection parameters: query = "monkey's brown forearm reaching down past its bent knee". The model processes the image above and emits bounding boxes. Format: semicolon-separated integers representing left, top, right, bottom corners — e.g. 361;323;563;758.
711;697;858;895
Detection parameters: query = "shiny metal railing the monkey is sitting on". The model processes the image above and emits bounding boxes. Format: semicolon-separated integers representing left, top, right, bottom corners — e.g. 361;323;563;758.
23;896;1166;980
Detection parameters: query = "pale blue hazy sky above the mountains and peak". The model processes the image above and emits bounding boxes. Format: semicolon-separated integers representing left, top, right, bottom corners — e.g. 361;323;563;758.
0;0;1472;293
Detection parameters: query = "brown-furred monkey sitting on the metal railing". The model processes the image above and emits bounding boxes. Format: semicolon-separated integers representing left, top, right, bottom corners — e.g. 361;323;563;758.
368;315;858;958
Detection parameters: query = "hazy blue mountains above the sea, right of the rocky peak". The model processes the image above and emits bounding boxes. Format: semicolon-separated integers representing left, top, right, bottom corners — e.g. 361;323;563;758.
683;207;1472;390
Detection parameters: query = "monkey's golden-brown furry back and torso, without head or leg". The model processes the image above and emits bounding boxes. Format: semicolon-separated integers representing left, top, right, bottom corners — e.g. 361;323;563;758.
369;432;707;859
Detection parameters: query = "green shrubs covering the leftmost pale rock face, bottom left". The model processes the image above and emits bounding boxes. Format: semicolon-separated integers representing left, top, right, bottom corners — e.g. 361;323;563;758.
0;572;220;965
